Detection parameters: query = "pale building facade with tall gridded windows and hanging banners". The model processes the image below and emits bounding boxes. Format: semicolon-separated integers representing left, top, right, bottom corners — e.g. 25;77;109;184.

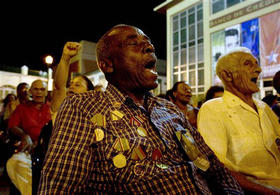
154;0;280;103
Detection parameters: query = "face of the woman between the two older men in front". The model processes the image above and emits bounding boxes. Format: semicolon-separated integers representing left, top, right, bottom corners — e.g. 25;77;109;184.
173;83;192;104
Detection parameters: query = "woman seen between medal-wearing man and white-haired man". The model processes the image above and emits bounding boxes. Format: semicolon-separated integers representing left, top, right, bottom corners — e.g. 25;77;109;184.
172;81;198;128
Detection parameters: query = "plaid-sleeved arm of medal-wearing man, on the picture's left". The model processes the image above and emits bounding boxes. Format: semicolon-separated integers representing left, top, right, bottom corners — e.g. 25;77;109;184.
38;97;93;194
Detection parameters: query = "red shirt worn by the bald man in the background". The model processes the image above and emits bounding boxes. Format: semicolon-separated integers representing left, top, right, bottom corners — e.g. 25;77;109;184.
8;102;51;141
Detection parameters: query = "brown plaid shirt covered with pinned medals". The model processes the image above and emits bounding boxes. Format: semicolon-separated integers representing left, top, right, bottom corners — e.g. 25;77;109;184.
39;84;243;194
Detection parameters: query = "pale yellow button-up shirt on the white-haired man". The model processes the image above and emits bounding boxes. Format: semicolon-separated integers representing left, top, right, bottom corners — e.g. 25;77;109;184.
198;91;280;188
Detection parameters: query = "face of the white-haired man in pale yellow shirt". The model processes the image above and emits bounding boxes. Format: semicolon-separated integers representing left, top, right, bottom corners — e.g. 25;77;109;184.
233;53;262;95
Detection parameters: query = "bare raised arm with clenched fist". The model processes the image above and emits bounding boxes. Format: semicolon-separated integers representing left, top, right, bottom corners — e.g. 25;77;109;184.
51;42;81;112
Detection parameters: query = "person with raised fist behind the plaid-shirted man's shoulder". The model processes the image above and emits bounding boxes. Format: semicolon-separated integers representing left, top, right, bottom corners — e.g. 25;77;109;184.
51;42;94;123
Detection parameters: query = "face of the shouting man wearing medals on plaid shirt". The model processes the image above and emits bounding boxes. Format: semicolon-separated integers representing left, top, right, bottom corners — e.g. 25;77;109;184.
111;27;158;91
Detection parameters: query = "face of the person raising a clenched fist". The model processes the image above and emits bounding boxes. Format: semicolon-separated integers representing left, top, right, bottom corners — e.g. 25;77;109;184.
67;76;87;96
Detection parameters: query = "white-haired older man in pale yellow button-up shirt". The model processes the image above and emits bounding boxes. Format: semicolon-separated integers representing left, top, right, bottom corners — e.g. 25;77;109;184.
198;47;280;194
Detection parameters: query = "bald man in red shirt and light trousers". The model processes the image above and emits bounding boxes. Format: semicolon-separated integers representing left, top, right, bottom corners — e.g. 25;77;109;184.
6;80;51;194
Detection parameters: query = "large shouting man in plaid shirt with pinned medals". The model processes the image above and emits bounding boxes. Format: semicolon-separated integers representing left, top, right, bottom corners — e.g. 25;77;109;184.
38;25;242;194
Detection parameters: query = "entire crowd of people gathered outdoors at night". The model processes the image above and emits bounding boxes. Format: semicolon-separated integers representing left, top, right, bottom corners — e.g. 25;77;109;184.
1;25;280;195
